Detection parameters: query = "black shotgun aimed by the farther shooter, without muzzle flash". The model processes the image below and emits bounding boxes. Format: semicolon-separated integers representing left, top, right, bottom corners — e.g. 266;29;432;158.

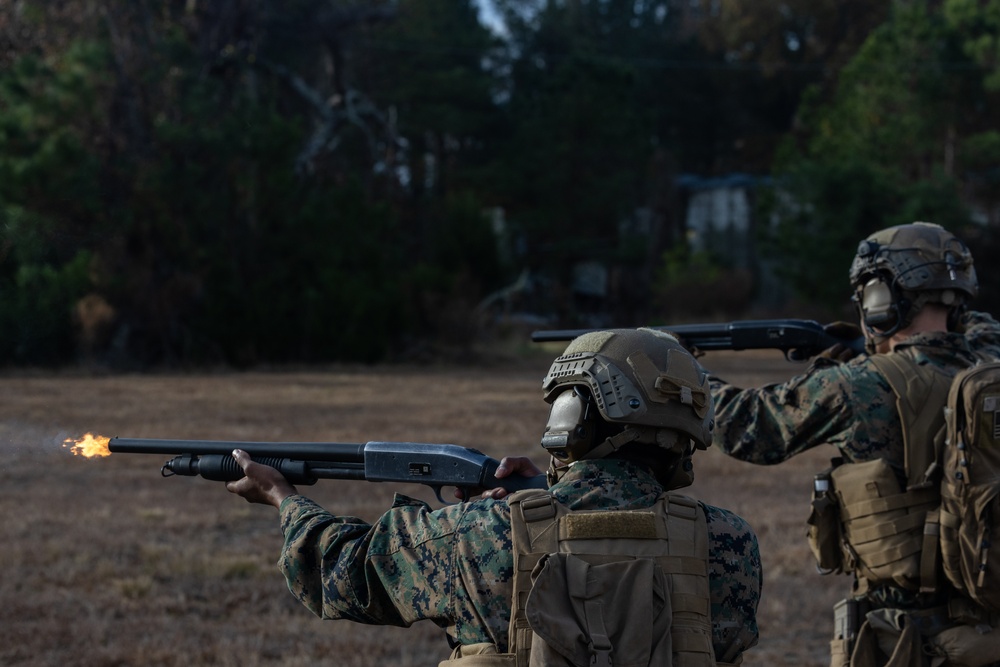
531;319;865;361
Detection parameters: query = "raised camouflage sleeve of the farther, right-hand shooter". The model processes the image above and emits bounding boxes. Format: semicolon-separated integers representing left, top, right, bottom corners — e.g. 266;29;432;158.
712;357;899;465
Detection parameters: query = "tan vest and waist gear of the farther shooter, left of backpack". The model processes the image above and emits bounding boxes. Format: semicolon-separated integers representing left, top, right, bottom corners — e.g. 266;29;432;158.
808;353;1000;667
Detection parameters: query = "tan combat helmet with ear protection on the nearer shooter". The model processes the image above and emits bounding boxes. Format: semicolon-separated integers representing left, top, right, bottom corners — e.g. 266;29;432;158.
542;329;715;484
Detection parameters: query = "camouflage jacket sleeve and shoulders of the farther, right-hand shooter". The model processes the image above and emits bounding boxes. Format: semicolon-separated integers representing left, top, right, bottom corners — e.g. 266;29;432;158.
712;312;1000;469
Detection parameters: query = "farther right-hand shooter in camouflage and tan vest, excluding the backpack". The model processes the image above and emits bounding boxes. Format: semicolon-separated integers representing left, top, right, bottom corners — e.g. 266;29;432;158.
713;223;1000;667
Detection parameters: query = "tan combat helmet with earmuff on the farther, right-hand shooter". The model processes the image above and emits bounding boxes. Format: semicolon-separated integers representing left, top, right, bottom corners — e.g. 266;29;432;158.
850;222;979;339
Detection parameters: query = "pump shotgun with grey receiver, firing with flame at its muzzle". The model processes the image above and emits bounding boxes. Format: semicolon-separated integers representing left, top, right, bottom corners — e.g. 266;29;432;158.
108;438;547;503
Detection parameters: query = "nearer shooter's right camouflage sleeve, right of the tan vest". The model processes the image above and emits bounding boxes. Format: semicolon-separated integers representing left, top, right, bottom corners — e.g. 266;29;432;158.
702;503;763;662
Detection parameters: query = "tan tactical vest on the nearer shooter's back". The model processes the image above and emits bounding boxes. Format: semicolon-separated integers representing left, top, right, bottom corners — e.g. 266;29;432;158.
440;490;738;667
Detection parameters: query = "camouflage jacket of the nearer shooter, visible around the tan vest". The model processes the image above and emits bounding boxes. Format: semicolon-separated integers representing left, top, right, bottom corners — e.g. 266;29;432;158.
279;460;761;656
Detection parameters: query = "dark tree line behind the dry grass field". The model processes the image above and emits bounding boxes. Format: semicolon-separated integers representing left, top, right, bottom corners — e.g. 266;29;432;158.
0;0;1000;367
